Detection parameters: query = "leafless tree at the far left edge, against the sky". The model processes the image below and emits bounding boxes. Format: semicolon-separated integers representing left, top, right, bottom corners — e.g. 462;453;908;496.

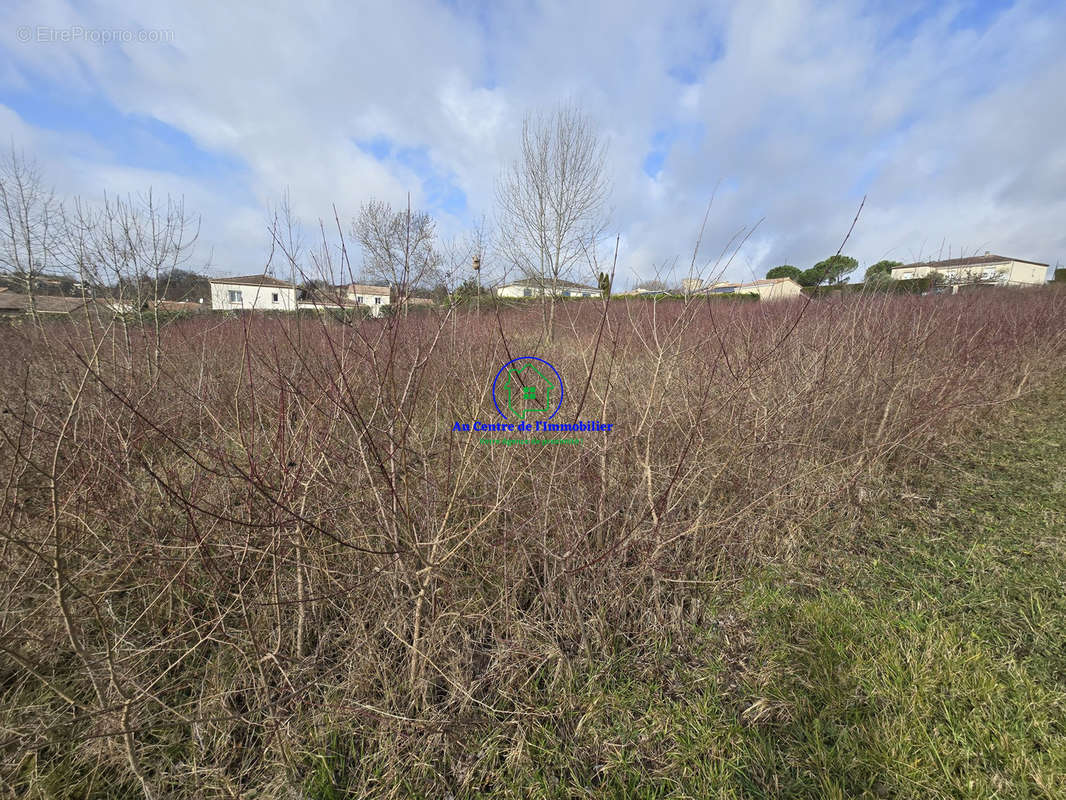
0;146;59;320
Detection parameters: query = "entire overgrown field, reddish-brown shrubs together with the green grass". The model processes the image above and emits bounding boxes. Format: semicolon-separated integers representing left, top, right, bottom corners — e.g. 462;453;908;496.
0;289;1066;798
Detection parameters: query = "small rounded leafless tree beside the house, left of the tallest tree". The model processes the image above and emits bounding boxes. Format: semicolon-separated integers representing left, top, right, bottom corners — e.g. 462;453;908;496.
352;198;441;304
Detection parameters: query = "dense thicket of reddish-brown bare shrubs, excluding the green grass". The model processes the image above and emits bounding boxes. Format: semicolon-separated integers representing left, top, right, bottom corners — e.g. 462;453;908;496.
0;273;1066;797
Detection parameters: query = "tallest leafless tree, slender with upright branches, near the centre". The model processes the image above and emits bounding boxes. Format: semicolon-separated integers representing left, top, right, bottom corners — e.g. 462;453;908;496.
496;105;610;340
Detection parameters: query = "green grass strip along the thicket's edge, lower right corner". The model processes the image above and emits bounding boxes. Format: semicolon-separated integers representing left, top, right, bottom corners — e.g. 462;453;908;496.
311;389;1066;800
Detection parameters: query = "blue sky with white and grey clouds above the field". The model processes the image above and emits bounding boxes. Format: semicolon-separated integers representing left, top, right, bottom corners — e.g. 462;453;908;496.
0;0;1066;285
